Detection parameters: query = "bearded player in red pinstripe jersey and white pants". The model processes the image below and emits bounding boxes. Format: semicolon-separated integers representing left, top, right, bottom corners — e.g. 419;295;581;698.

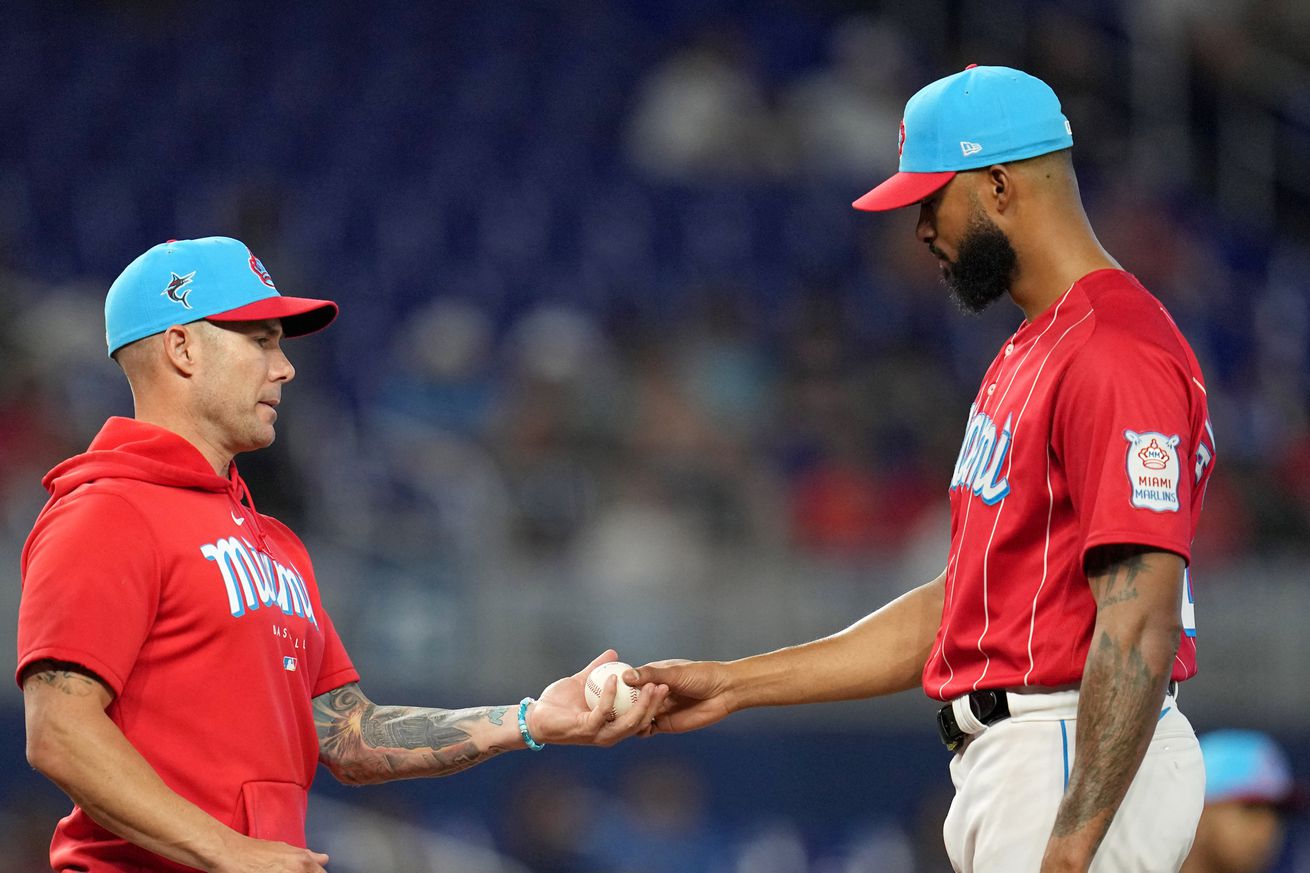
626;66;1214;873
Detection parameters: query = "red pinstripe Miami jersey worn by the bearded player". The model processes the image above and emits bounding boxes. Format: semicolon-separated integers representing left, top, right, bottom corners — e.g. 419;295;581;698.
924;270;1214;700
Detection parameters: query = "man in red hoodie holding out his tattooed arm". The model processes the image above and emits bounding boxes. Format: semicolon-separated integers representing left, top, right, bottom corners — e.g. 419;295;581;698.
16;237;668;873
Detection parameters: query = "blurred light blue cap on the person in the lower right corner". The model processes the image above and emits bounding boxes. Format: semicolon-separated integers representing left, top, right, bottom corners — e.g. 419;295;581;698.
1200;730;1303;807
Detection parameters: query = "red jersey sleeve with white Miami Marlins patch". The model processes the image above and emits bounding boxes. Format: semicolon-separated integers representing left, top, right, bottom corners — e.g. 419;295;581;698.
1051;330;1195;561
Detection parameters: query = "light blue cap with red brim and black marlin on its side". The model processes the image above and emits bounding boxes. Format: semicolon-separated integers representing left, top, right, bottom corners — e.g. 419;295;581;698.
105;236;337;355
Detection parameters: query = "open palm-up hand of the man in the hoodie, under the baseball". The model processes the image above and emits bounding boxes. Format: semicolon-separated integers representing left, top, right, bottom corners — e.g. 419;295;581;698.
528;649;668;746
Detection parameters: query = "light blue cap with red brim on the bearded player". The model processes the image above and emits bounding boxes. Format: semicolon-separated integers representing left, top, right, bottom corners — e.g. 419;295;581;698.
852;64;1073;212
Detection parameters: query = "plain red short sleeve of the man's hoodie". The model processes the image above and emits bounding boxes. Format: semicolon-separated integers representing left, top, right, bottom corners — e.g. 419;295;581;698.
14;492;161;696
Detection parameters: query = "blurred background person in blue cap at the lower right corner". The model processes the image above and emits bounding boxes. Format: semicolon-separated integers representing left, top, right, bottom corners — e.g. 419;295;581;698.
1182;730;1302;873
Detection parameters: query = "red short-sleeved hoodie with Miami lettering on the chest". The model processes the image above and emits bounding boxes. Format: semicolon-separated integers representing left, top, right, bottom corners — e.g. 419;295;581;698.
17;418;359;870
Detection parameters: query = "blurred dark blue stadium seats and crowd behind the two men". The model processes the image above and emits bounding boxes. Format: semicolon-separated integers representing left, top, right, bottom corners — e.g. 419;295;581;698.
0;0;1310;873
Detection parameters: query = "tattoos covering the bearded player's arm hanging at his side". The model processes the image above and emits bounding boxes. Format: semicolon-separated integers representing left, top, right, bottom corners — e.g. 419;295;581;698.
1052;545;1178;851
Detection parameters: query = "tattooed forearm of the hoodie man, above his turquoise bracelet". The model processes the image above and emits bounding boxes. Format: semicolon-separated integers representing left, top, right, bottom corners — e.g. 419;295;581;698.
314;683;507;784
